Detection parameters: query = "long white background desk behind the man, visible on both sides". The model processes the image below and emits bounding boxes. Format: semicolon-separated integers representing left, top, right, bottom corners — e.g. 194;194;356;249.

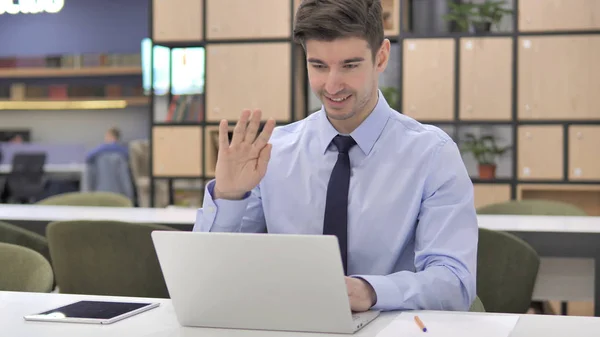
0;205;600;316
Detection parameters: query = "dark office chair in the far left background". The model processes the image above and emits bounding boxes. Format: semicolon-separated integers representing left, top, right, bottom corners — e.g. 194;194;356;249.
4;152;46;203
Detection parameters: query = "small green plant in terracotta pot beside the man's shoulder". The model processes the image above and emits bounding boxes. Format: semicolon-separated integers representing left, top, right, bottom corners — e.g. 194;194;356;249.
462;133;510;179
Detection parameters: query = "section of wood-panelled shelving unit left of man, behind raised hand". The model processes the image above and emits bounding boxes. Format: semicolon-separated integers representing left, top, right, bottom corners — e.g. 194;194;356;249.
149;0;306;206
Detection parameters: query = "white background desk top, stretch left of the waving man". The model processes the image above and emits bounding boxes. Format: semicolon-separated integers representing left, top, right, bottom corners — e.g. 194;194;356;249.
0;204;198;226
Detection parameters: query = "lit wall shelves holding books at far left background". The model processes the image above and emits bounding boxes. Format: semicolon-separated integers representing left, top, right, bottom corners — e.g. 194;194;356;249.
0;54;149;111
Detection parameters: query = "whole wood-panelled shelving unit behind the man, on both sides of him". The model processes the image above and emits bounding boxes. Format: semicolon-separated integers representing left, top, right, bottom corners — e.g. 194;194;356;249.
149;0;600;210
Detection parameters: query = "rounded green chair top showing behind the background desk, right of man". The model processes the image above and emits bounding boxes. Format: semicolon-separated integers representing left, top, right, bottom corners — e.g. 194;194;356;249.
477;199;587;216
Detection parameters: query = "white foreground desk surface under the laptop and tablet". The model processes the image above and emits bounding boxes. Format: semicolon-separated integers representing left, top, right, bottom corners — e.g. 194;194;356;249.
0;292;600;337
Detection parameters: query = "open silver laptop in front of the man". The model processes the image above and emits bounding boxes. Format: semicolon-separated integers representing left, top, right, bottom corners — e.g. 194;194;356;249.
152;231;379;334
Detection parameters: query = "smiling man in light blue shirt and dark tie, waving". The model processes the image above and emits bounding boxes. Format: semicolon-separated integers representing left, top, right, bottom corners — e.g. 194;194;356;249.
194;0;478;311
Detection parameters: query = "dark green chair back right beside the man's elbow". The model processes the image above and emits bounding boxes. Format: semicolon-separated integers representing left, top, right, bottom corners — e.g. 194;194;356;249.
477;228;540;314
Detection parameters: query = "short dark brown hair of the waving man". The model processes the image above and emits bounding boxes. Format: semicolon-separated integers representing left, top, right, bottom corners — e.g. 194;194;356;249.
293;0;384;59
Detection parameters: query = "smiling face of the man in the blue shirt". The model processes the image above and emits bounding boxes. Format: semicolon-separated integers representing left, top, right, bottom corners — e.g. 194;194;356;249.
305;38;389;120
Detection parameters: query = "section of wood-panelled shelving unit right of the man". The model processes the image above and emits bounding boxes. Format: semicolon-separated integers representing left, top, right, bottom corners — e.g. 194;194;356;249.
386;0;600;215
